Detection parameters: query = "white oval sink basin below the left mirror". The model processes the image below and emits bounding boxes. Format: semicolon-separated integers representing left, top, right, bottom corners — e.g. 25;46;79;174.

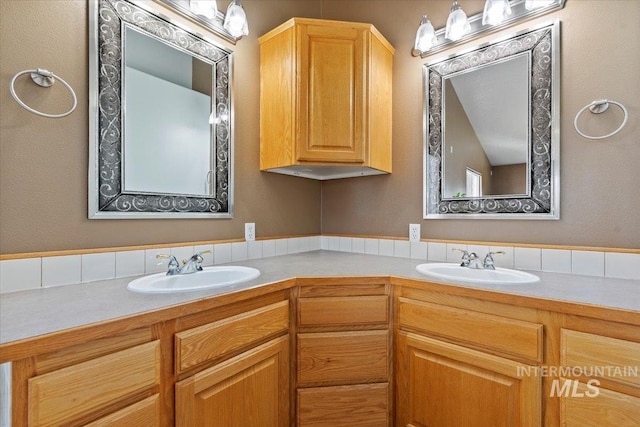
127;266;260;294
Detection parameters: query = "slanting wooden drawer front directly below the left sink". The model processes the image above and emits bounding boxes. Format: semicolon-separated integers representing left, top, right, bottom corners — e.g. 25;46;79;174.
175;301;289;373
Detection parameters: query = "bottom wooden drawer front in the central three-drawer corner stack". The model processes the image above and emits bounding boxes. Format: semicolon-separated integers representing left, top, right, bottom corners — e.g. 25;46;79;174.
297;383;389;427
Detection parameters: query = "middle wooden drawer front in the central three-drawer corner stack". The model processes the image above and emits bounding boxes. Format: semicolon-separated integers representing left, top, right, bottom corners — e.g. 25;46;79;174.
298;331;389;387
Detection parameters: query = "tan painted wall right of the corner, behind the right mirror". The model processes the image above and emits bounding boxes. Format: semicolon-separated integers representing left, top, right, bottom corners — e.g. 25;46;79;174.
322;0;640;248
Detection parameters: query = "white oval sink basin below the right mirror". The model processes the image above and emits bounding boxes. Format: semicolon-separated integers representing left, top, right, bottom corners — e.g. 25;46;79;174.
416;263;540;285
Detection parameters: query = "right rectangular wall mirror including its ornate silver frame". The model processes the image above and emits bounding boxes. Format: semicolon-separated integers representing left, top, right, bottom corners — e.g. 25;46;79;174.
424;22;560;219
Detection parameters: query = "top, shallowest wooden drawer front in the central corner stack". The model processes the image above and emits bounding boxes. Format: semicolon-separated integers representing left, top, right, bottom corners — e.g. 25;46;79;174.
298;296;389;326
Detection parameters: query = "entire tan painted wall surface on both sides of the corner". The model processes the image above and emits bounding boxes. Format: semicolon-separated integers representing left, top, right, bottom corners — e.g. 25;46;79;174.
0;0;640;253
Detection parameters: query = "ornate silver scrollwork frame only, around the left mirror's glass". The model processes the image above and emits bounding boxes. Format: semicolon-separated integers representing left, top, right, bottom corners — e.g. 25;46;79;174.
89;0;233;219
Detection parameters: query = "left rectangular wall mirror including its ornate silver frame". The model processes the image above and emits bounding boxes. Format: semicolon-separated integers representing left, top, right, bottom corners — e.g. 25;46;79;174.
89;0;233;219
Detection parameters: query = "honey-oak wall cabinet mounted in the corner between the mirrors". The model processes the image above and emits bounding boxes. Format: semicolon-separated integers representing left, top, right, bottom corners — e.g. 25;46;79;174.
259;18;394;179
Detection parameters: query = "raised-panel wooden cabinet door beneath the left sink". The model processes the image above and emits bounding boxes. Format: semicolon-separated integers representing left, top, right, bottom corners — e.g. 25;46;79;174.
175;336;290;427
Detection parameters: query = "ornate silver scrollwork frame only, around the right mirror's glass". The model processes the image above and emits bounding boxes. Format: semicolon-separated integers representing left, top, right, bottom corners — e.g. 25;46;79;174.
423;21;560;219
